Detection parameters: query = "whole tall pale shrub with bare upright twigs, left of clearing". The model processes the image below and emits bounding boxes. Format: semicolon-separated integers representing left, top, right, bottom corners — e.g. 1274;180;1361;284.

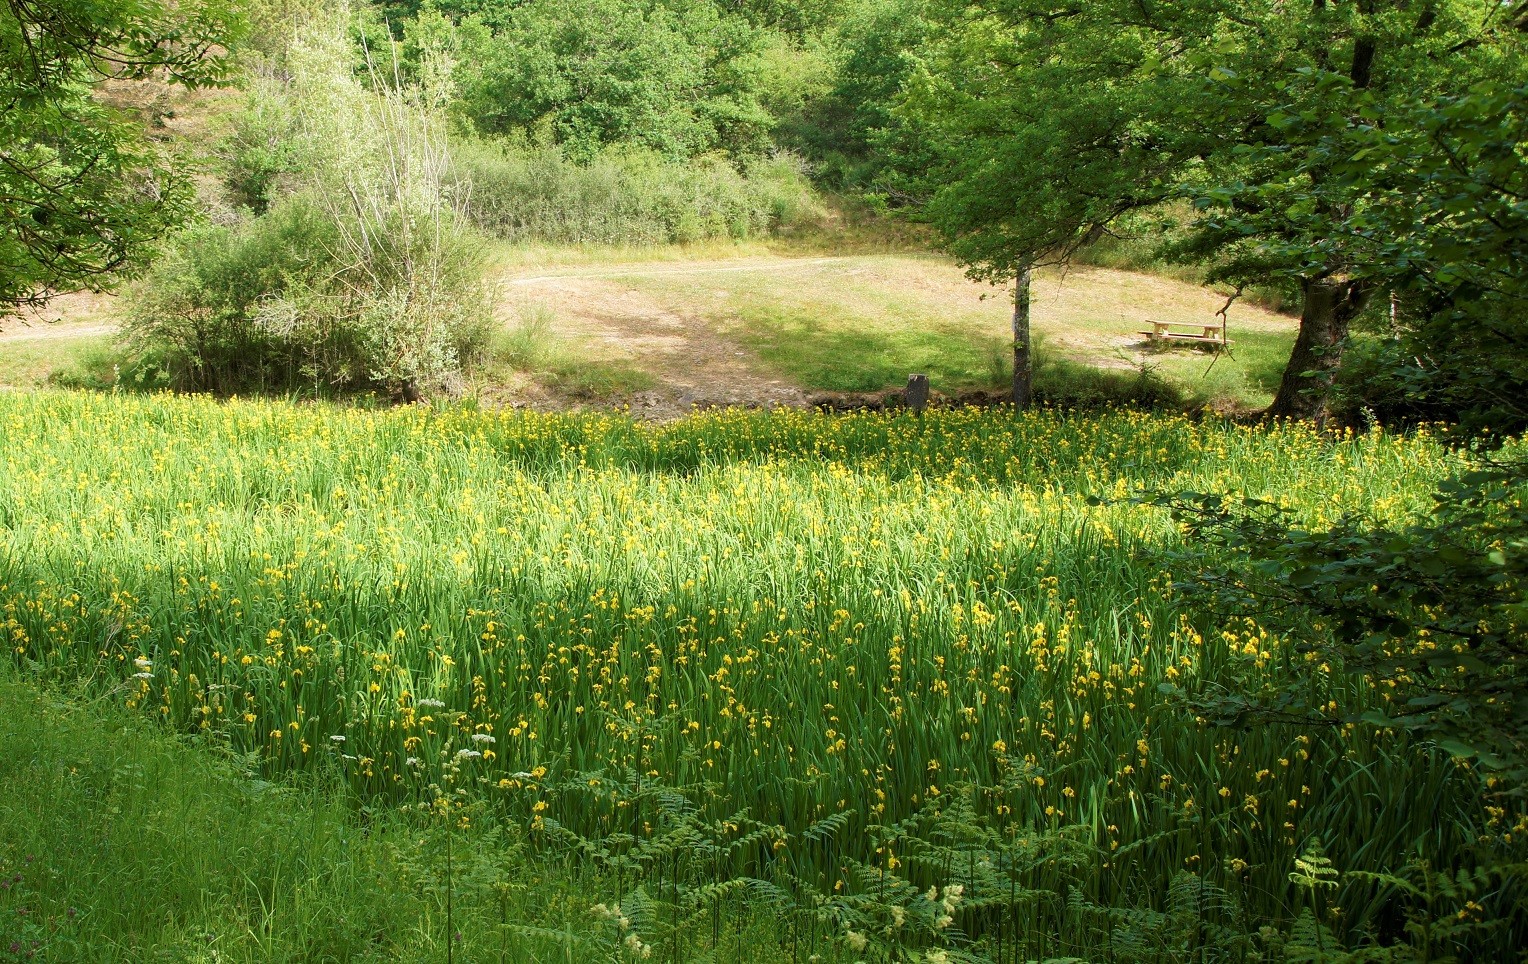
125;11;490;400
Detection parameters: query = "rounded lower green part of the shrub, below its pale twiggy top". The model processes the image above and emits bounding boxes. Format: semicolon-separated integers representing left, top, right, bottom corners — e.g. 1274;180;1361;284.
124;196;490;400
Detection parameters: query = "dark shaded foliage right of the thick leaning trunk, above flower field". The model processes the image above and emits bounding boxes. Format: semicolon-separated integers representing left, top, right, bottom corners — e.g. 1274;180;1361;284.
1301;84;1528;438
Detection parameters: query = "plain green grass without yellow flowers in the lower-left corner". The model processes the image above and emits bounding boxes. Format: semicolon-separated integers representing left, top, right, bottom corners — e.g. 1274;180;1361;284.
0;669;861;964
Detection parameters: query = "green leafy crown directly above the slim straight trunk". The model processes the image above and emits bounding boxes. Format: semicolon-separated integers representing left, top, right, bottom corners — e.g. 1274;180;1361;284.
902;3;1191;283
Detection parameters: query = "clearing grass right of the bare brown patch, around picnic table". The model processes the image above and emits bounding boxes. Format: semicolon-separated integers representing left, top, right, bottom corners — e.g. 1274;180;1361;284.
565;252;1294;409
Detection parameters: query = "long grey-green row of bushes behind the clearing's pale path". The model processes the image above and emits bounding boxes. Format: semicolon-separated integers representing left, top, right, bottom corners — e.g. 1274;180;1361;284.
449;142;822;244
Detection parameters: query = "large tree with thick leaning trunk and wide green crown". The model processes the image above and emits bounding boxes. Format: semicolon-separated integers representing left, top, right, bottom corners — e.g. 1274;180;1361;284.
905;0;1519;419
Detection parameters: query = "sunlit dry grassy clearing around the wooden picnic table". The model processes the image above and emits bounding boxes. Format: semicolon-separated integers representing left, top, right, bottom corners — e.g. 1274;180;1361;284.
494;247;1296;409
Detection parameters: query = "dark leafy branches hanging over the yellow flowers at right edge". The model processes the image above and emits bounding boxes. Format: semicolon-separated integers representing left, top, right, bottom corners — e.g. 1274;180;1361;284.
1172;464;1528;797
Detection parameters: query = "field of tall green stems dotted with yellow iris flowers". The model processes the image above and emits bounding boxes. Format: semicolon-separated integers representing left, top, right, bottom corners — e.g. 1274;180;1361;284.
0;393;1522;961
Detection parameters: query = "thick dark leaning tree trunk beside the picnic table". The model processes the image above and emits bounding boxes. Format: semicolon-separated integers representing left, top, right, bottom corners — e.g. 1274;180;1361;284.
1265;278;1369;423
